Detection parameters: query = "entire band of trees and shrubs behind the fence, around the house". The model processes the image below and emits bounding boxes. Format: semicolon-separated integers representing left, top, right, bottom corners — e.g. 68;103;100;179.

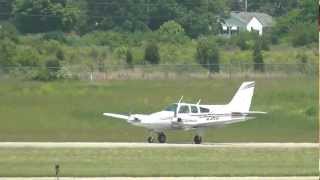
0;0;318;79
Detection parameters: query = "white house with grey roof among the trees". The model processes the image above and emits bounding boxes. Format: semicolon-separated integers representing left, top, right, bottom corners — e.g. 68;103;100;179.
221;12;273;35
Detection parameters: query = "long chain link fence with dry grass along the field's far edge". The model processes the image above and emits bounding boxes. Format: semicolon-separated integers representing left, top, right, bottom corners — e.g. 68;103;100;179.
0;63;318;81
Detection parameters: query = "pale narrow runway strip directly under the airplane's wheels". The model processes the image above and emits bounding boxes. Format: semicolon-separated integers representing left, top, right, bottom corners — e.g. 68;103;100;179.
0;142;320;148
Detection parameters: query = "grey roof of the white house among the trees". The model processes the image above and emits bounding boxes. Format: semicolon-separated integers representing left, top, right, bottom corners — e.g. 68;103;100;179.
225;12;273;27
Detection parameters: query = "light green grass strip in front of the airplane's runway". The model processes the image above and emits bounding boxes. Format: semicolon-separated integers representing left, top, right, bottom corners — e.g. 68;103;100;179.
0;148;318;177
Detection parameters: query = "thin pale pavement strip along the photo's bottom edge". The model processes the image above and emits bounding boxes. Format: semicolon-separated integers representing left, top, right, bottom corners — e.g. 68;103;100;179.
0;176;319;180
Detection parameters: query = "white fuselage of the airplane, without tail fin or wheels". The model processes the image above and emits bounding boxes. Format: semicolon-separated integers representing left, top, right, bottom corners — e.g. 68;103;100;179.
128;103;246;132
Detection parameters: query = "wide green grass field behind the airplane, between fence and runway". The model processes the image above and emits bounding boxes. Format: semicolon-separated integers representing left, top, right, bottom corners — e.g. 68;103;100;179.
0;77;318;142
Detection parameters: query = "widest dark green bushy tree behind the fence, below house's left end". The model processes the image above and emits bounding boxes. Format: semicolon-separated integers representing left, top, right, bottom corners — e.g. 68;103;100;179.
196;36;220;73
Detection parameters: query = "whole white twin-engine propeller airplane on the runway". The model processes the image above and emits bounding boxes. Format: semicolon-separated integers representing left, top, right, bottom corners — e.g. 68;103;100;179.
103;81;266;144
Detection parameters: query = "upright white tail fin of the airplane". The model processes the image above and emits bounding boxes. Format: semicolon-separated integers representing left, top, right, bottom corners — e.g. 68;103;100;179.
227;81;255;112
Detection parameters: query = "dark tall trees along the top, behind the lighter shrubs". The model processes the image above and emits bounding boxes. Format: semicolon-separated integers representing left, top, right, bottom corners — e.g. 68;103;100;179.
0;0;317;37
